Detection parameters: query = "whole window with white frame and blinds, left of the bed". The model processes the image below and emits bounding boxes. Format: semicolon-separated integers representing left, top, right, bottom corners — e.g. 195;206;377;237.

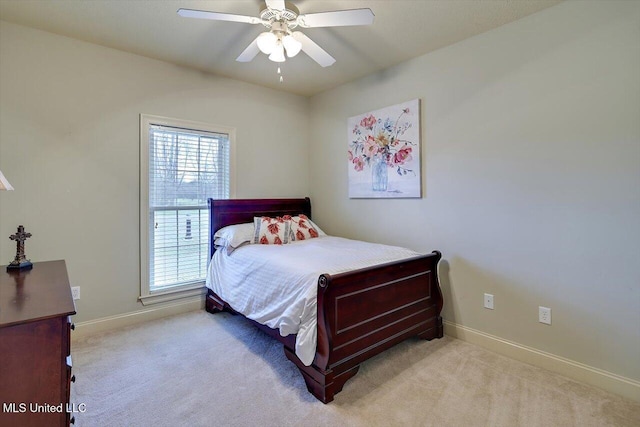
140;115;234;304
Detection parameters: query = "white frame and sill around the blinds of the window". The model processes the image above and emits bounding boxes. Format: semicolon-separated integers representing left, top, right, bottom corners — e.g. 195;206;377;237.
138;114;236;305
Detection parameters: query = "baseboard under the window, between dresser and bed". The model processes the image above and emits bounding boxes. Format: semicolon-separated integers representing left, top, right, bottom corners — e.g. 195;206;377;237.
71;296;204;341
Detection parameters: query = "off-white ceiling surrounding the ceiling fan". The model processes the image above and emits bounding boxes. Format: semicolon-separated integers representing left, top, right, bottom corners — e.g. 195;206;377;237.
0;0;561;95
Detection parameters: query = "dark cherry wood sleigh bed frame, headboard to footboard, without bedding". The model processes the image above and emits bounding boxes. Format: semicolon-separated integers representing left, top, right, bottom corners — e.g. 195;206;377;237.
206;198;443;403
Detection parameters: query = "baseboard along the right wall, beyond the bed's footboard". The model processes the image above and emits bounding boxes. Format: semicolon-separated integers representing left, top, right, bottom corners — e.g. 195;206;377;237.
443;320;640;402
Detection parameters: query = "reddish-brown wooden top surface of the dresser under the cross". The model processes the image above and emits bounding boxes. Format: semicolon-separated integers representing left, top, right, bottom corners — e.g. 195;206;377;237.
0;260;76;328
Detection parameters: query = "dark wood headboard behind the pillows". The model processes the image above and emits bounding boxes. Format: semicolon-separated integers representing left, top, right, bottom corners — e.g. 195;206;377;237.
208;197;311;259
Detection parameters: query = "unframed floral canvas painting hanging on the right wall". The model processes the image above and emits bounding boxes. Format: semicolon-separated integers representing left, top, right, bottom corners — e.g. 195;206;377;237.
347;99;422;198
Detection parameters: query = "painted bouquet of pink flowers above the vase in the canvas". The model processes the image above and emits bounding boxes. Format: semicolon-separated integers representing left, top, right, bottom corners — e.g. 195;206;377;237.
348;108;416;175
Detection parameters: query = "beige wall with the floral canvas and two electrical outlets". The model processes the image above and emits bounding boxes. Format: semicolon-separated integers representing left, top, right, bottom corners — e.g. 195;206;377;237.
310;2;640;380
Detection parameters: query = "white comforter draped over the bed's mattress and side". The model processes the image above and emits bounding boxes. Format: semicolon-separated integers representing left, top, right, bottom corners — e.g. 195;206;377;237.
202;236;420;366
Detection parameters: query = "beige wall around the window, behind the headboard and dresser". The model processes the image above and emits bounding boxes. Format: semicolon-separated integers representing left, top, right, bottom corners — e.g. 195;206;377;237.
0;22;309;322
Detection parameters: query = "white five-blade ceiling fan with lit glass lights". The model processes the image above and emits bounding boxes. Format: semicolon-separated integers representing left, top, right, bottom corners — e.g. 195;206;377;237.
178;0;374;67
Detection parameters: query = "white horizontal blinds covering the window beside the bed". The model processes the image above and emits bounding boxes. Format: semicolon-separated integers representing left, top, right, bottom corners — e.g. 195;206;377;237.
147;123;231;293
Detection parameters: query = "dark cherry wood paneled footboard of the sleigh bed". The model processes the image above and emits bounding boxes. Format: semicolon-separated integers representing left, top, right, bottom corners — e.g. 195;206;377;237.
285;251;443;403
